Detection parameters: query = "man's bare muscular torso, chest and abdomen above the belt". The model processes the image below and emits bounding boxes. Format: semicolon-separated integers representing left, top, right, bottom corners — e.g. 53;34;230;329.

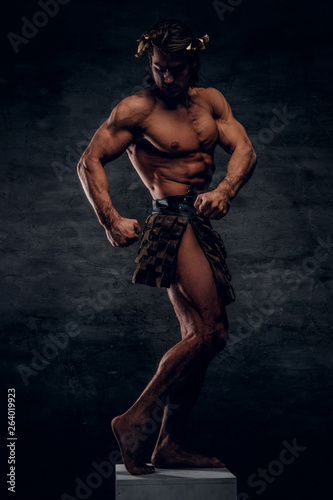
127;89;219;199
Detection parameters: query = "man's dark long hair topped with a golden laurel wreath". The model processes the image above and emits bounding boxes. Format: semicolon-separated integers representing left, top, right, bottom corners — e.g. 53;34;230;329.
136;19;209;87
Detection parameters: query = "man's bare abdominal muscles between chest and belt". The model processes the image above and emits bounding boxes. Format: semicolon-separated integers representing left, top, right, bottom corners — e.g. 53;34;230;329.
128;148;215;200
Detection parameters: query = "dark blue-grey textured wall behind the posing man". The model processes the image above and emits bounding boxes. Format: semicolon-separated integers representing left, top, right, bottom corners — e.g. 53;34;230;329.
0;0;333;500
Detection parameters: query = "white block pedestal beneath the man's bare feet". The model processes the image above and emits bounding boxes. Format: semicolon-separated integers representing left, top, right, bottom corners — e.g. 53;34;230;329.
116;464;237;500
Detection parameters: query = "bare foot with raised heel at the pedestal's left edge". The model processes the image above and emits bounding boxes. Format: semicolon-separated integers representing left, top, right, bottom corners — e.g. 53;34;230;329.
111;415;155;476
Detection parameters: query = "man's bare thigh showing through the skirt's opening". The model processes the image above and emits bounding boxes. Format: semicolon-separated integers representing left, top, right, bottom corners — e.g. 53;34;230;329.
168;223;228;338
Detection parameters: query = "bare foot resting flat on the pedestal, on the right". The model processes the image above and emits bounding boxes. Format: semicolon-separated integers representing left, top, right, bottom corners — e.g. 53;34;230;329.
151;442;225;469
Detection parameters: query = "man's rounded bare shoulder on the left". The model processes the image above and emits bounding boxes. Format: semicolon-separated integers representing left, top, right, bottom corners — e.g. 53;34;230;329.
108;89;156;128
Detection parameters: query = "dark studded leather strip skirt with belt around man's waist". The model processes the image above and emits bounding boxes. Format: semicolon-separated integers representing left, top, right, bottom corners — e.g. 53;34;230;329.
132;192;235;305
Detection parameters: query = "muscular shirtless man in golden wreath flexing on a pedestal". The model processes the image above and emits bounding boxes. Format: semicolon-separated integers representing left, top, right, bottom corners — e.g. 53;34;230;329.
78;20;256;474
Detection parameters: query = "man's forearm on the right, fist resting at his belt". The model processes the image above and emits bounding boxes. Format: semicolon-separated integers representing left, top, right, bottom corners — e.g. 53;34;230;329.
216;146;257;200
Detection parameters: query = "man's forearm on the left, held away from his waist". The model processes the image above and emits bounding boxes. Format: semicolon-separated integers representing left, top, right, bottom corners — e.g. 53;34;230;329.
78;155;120;229
